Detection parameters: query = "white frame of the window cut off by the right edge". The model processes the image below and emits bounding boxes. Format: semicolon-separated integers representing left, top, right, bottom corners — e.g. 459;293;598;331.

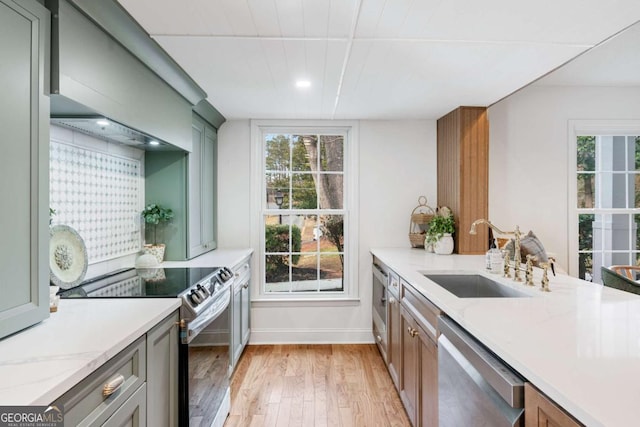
567;120;640;277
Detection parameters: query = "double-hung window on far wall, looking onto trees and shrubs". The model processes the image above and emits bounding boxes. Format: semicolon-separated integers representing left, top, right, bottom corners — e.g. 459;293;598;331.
254;122;352;298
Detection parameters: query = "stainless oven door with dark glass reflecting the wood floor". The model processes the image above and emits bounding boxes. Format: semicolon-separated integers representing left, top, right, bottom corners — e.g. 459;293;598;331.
179;287;231;427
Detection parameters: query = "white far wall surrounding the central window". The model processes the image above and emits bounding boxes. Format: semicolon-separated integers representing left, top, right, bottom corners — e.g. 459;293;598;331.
218;120;437;343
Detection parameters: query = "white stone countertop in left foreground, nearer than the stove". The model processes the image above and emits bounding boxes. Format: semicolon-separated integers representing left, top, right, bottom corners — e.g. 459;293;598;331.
0;298;180;406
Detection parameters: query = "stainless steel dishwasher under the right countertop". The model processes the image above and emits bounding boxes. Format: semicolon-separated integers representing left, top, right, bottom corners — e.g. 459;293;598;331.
438;316;524;427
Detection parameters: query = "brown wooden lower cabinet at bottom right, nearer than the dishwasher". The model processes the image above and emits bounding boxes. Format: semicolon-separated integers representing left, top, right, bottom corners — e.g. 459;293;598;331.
524;383;582;427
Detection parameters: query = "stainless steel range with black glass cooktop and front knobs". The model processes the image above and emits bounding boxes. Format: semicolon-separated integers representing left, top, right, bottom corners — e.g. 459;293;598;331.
60;267;234;427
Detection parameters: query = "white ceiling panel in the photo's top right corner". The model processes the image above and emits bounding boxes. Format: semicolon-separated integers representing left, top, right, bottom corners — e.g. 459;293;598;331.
356;0;640;44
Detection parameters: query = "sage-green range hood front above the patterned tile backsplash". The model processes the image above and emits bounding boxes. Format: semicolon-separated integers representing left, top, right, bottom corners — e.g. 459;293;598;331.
47;0;192;151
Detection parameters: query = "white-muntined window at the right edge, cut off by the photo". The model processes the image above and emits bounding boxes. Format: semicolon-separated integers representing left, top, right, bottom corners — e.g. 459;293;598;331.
572;125;640;282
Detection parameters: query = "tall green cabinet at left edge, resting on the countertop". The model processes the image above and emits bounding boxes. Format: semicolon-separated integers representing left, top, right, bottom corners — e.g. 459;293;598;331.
0;0;50;338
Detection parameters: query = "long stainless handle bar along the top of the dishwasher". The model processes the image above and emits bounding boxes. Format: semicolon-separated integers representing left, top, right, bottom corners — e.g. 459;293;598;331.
438;316;524;408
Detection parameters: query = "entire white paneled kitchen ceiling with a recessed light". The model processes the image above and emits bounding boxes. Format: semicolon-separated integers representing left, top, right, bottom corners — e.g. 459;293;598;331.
119;0;640;119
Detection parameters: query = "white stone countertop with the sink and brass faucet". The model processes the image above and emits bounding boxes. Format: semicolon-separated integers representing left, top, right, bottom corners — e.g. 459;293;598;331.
371;248;640;427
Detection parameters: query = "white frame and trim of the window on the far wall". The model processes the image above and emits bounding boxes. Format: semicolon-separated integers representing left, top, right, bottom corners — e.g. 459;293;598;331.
251;120;359;306
